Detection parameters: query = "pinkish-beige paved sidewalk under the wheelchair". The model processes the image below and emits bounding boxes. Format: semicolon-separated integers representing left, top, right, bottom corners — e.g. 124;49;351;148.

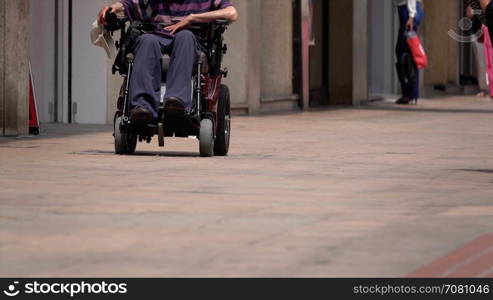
0;97;493;277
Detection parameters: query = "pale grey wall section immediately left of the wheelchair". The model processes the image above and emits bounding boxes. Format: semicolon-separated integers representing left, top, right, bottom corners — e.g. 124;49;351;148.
29;0;109;124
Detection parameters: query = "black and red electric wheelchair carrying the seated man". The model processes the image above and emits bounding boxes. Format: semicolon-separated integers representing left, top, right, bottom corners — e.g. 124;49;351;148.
105;11;231;157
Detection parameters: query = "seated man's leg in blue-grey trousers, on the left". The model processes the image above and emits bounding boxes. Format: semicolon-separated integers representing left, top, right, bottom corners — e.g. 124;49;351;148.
130;34;171;119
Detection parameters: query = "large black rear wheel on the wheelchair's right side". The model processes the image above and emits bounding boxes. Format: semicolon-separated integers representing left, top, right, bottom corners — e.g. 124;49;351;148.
214;84;231;156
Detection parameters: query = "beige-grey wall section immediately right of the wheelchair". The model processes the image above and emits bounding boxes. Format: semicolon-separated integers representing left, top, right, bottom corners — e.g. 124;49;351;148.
224;0;297;113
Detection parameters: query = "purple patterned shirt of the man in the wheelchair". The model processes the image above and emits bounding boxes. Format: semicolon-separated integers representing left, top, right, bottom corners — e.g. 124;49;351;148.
120;0;233;37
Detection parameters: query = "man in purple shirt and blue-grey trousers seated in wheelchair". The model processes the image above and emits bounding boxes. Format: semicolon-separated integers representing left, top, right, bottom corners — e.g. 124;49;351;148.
98;0;238;123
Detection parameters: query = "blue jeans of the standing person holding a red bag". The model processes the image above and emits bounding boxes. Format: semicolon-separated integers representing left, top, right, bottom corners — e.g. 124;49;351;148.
395;2;424;99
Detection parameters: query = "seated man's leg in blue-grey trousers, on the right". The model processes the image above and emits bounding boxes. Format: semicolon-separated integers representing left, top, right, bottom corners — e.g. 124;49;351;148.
165;30;198;112
